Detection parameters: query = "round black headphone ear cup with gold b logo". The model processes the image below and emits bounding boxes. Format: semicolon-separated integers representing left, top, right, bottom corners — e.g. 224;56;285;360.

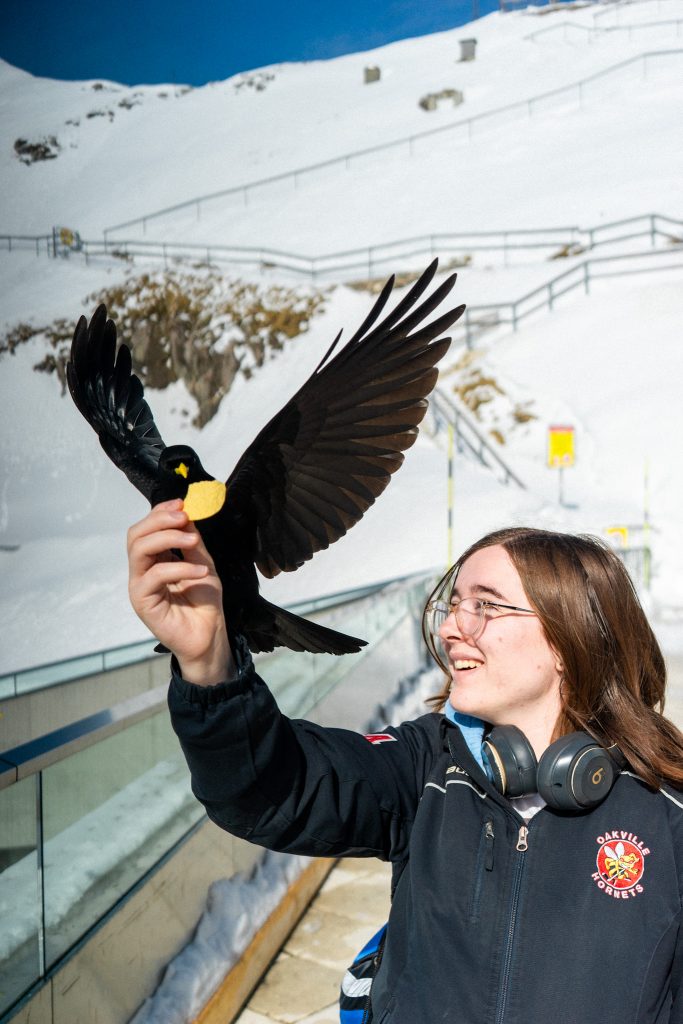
537;732;617;811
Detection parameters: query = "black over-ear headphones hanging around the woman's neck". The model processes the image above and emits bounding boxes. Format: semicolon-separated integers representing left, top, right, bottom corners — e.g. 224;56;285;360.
482;725;626;811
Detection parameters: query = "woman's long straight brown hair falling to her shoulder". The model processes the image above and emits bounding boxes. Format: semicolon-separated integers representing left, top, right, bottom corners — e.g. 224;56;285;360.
422;526;683;788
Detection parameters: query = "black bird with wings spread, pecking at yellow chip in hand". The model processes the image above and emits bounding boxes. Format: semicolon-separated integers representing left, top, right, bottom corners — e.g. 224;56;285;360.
67;260;465;654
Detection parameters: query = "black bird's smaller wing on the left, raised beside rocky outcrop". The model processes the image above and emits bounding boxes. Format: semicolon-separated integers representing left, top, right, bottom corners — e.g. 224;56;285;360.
67;305;166;501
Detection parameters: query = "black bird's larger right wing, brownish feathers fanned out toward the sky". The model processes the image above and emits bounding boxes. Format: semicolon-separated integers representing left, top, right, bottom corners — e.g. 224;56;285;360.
227;260;465;578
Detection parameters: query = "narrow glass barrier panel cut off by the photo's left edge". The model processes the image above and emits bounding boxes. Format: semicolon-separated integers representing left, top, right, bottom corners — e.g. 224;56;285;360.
0;775;42;1014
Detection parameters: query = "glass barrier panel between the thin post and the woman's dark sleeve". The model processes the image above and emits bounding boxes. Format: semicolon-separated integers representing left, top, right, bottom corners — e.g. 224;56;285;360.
43;710;204;967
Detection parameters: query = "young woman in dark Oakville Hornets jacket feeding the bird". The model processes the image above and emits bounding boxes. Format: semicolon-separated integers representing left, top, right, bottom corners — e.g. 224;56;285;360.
129;503;683;1024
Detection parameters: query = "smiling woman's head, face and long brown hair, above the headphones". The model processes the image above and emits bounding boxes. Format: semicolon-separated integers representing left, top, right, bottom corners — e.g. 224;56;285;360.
423;527;683;785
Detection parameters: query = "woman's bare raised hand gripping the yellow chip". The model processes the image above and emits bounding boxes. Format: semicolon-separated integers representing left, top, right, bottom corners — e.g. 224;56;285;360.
128;501;236;686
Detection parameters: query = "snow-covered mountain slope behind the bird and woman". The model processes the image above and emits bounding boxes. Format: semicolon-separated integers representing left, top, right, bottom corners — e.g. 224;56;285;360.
0;0;683;673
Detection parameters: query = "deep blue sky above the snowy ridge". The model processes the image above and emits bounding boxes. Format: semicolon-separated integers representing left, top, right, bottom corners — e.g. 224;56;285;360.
0;0;498;85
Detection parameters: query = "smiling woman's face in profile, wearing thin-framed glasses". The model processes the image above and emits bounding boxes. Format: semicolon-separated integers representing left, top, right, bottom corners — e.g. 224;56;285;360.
439;545;561;746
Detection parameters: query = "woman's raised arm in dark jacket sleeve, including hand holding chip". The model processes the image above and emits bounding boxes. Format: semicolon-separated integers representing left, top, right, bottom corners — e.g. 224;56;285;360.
128;501;433;858
